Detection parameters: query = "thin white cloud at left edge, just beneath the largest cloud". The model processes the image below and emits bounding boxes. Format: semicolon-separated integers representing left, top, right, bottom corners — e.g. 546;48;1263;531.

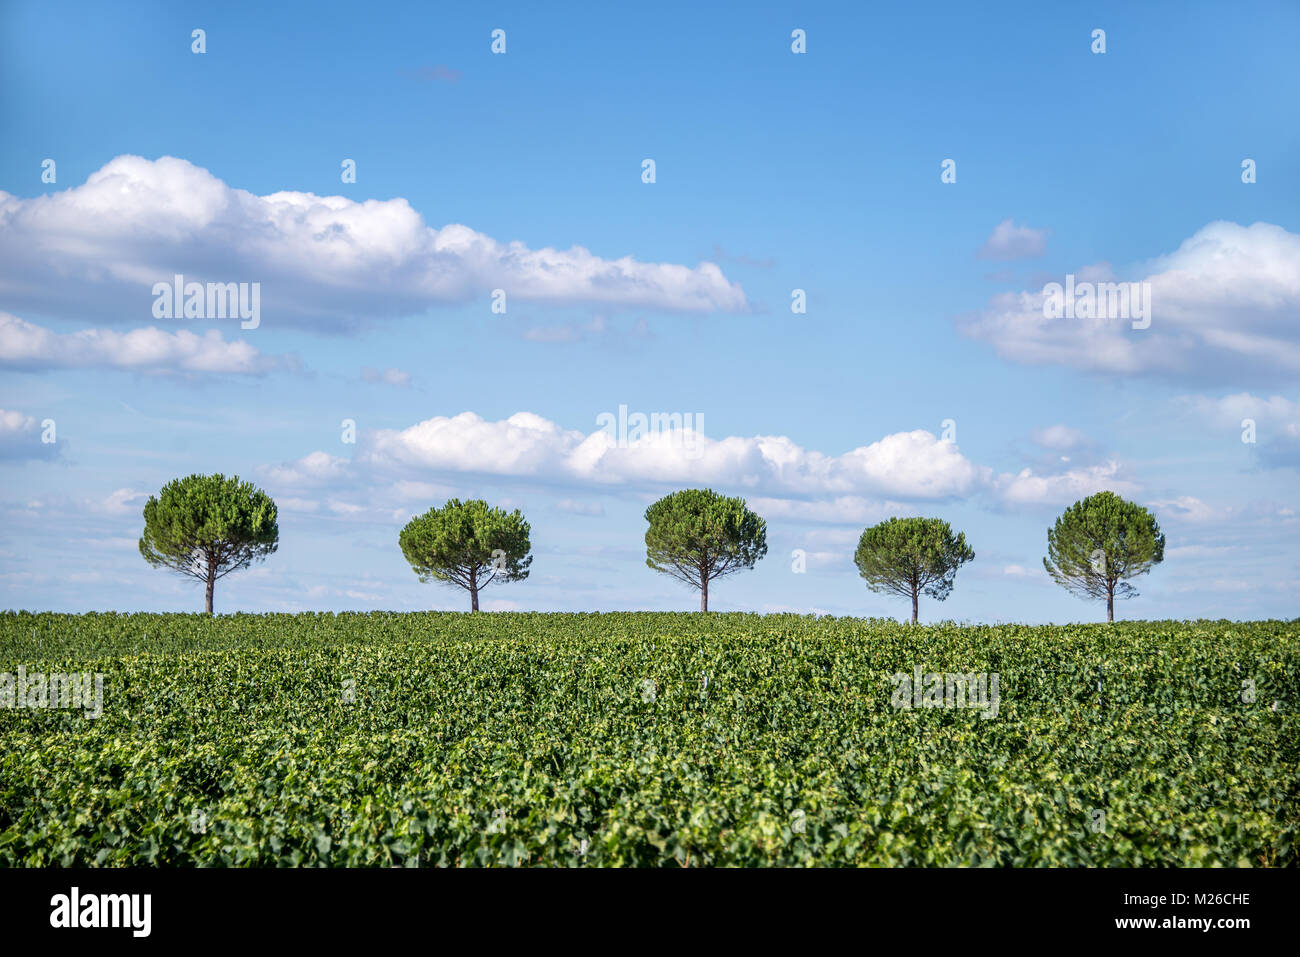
0;312;289;376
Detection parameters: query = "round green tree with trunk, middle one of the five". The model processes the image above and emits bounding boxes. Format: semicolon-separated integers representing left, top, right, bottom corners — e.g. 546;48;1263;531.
646;489;767;611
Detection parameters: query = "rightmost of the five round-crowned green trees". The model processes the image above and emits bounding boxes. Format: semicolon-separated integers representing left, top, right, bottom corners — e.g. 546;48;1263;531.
1043;492;1165;622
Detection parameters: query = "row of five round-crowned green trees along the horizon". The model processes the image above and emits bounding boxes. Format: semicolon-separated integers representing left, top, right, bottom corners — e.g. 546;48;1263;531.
140;475;1165;623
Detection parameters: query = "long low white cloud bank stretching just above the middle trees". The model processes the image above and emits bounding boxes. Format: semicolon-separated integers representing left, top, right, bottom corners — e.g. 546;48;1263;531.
260;412;1159;525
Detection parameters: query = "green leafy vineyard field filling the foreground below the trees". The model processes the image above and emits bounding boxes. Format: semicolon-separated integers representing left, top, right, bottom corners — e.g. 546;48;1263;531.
0;612;1300;867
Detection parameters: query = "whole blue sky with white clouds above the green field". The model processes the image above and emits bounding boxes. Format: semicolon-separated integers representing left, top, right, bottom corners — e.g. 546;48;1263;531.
0;3;1300;622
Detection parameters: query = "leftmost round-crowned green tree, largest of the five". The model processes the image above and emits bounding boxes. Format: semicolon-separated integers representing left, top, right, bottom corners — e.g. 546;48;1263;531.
140;475;280;615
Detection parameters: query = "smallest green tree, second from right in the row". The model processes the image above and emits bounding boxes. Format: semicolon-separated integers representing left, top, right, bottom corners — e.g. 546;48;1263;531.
853;519;975;624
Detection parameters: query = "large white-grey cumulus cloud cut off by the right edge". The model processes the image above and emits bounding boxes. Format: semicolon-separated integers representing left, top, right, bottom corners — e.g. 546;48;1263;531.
959;221;1300;382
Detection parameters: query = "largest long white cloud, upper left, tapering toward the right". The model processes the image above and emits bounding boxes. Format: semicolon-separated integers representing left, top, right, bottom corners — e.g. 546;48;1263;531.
0;156;748;326
